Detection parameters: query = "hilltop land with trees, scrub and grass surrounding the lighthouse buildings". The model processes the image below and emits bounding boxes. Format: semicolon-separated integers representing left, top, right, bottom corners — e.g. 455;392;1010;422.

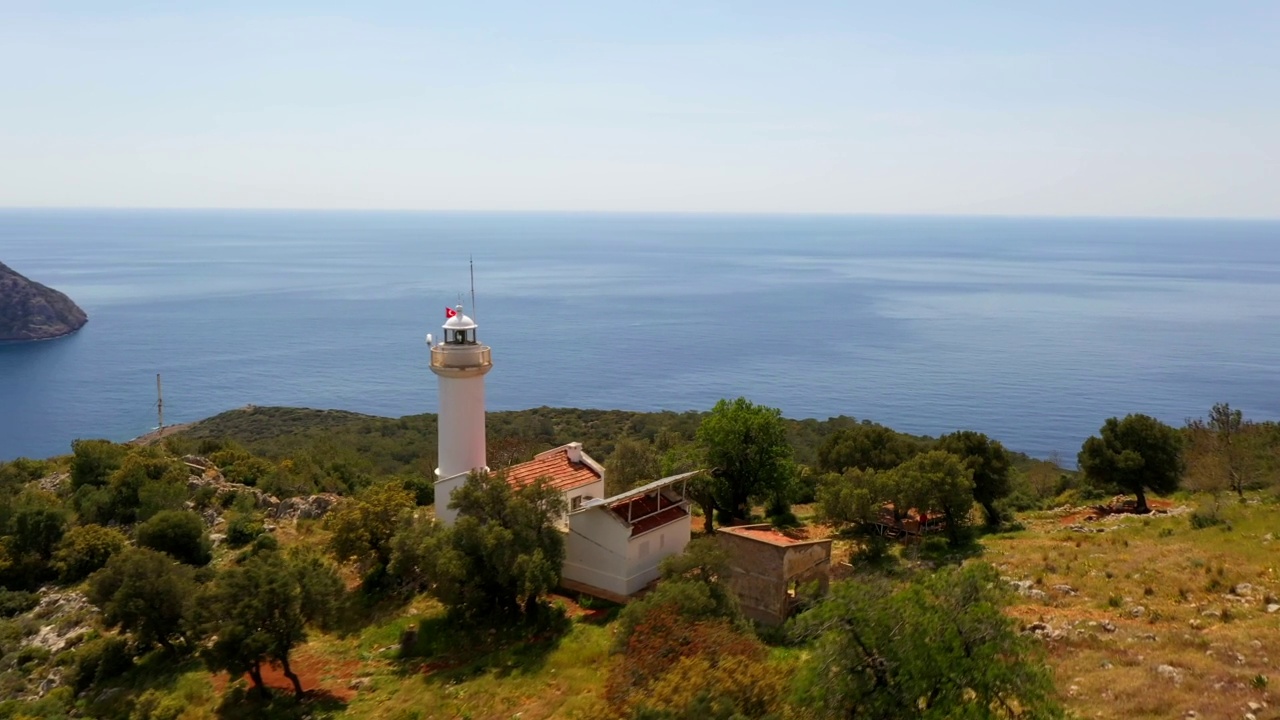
0;400;1280;720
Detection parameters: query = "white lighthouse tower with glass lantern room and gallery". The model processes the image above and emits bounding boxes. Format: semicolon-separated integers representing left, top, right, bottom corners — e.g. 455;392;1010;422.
426;305;493;525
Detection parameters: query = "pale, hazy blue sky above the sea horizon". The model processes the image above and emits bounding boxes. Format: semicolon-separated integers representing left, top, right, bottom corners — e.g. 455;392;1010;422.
0;0;1280;218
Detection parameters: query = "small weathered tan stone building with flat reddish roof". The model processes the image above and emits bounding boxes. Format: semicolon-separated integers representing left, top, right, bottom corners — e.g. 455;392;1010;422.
717;524;831;625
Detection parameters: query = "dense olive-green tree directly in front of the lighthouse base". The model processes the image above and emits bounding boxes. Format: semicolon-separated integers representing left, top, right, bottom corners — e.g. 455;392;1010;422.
429;473;564;623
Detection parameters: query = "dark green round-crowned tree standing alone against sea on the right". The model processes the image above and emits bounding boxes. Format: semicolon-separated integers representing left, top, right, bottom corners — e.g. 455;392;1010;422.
1076;415;1183;512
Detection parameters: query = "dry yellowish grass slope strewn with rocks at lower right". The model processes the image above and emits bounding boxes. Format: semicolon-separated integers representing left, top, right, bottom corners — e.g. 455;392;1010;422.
983;491;1280;719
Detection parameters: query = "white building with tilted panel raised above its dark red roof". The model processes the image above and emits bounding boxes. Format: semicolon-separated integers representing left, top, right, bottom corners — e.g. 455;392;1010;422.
561;473;698;602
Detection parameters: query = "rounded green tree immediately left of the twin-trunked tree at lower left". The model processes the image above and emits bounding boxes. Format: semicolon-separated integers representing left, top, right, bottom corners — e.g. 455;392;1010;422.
87;547;195;652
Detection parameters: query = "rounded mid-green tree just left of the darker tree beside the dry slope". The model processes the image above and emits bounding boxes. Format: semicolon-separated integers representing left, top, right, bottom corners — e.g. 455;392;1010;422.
890;450;973;546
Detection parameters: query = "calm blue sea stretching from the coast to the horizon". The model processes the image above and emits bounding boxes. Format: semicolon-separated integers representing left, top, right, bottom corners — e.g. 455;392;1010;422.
0;210;1280;461
